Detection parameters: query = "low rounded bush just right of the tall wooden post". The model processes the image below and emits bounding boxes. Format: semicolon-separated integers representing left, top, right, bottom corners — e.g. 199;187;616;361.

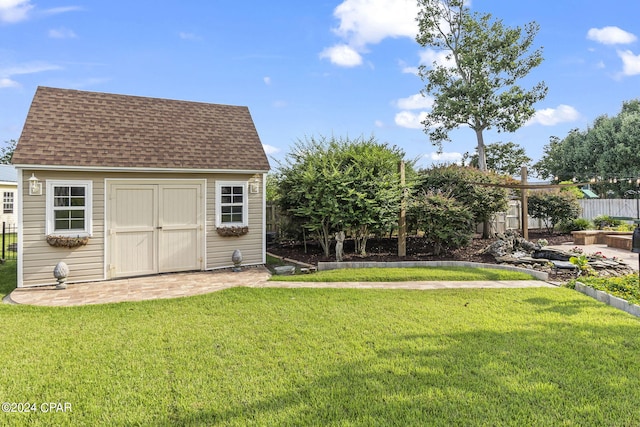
408;192;473;255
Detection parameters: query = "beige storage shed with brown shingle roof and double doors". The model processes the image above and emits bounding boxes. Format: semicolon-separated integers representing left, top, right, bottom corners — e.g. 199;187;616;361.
13;87;269;287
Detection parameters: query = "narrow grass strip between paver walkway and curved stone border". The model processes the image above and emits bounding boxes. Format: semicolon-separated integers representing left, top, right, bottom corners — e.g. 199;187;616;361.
271;267;535;282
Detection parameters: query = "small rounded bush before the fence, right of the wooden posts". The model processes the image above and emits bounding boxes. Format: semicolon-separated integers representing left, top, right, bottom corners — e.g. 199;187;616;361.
528;191;580;233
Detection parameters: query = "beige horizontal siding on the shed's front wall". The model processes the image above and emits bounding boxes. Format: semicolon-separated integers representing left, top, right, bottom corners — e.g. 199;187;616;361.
19;169;265;286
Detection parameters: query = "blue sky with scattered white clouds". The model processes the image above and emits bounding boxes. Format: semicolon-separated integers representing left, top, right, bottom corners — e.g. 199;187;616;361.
0;0;640;174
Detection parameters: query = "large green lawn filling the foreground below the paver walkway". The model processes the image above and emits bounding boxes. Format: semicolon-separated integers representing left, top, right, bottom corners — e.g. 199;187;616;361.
0;274;640;426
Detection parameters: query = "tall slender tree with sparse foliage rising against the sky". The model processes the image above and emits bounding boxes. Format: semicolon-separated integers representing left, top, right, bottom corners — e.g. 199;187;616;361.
416;0;547;170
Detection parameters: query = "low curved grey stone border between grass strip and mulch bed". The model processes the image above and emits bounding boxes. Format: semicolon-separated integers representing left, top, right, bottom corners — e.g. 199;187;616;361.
318;261;549;281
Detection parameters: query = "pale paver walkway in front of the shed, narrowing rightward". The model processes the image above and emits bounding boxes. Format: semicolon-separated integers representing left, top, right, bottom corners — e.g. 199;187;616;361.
7;267;554;306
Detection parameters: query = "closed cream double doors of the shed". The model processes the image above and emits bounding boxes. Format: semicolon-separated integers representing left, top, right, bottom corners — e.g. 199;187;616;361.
107;183;203;278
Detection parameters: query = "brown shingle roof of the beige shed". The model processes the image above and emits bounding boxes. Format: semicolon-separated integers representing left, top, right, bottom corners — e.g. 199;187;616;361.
12;87;269;171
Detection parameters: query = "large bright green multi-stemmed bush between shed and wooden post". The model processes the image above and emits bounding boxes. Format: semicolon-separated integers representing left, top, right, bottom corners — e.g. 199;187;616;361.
277;137;411;256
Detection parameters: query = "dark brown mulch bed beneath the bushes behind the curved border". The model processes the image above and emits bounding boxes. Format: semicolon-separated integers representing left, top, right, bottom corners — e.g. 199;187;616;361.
267;230;573;265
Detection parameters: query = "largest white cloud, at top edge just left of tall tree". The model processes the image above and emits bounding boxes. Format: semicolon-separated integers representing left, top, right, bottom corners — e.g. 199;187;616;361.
320;0;419;67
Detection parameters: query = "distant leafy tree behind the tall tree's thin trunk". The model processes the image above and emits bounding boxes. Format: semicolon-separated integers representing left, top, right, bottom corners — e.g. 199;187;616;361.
462;142;531;176
